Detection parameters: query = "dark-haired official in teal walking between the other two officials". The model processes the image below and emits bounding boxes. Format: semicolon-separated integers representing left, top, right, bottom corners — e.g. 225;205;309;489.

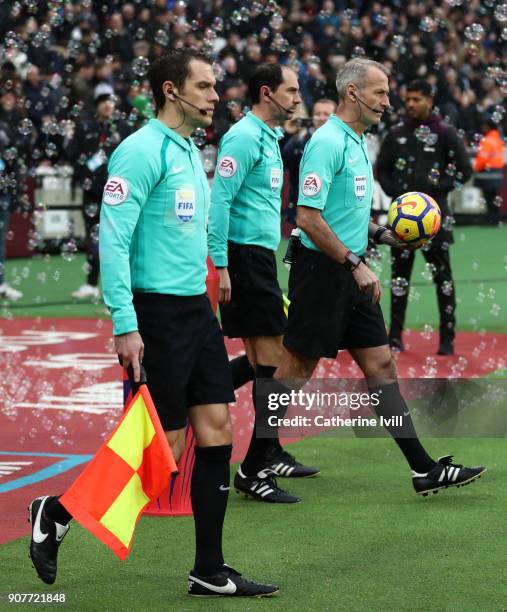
208;64;318;503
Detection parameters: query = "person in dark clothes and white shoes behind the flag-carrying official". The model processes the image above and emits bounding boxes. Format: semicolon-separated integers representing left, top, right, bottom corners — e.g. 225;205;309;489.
67;93;132;299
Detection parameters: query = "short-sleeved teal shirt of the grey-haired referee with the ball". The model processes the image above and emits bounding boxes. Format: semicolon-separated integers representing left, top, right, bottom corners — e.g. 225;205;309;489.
298;115;373;255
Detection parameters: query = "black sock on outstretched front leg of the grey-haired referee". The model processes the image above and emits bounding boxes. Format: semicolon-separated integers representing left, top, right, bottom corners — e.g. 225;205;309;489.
368;381;435;474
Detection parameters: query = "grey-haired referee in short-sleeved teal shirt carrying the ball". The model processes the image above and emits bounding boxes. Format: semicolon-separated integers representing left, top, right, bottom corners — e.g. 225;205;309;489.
268;59;485;494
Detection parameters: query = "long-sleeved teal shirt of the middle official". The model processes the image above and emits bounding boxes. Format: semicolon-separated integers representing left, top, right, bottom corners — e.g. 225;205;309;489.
208;112;283;266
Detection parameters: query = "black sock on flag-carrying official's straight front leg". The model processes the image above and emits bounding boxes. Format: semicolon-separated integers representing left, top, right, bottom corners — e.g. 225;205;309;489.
190;444;232;576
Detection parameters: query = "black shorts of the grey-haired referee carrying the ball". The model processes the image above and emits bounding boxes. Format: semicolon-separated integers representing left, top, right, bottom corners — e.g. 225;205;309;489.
283;245;389;358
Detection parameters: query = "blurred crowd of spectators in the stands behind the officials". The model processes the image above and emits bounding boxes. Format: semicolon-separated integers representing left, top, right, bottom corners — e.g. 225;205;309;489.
0;0;507;298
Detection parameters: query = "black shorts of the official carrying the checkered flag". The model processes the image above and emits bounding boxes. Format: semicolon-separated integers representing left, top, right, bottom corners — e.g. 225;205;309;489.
134;293;236;431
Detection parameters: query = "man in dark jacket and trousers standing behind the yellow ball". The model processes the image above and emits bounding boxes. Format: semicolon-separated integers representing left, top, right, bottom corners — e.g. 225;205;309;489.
377;80;472;355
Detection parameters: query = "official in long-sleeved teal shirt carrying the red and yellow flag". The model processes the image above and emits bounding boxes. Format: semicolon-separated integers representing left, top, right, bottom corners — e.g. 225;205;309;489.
30;49;278;597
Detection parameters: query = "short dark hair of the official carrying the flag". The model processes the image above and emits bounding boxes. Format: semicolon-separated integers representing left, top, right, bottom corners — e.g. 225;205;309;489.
148;49;213;110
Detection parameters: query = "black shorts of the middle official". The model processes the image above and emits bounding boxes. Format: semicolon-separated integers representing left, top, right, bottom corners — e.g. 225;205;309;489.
220;242;287;338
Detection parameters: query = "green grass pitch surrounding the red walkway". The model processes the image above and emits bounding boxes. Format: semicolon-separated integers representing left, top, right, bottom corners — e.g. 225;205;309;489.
0;227;507;612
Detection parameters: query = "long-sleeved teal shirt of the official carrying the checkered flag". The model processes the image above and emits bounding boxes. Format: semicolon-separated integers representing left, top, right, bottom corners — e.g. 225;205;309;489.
99;119;209;335
